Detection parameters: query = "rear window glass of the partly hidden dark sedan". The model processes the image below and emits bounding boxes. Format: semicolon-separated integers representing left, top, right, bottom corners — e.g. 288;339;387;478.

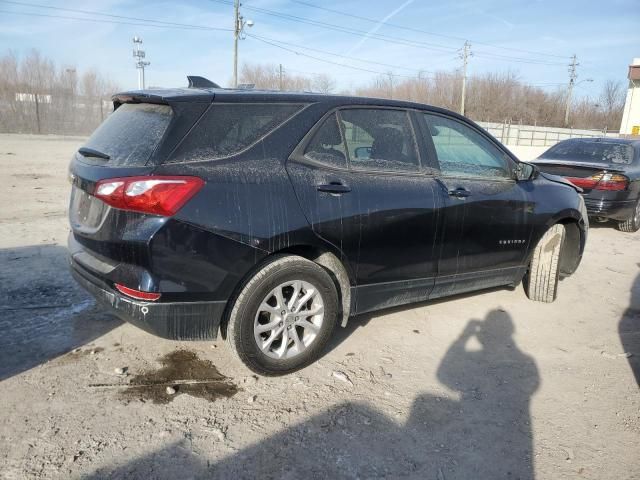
540;141;633;164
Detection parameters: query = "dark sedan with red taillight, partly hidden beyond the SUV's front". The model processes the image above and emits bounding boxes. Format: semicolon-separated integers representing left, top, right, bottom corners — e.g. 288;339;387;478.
532;138;640;232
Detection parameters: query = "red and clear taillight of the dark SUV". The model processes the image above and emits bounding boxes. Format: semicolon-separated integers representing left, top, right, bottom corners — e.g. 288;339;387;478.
94;176;204;217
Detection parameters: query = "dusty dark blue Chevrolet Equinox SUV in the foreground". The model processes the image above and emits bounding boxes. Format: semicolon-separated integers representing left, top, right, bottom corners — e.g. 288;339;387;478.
69;82;588;374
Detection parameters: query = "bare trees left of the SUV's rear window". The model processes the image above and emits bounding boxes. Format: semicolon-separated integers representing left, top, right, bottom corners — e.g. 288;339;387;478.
0;50;119;135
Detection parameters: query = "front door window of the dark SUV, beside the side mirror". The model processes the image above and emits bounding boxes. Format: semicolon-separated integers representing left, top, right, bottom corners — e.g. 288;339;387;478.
424;113;511;178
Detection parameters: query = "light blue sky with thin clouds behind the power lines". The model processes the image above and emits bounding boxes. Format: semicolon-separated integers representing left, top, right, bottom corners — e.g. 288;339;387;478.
0;0;640;95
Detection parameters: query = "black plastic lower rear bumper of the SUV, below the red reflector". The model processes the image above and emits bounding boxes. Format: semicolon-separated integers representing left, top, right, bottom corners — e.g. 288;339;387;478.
70;257;227;340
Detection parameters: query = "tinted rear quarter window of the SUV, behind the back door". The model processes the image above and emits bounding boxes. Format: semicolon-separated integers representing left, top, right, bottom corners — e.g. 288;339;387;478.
169;103;303;162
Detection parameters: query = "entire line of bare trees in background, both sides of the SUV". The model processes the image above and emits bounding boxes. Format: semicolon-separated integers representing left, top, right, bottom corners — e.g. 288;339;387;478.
0;50;626;135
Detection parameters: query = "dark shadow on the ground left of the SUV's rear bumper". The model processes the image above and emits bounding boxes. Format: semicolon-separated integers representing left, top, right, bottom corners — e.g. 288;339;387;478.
0;245;121;381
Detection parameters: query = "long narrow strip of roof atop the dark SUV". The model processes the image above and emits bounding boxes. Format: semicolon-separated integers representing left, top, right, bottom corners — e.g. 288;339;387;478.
112;87;460;117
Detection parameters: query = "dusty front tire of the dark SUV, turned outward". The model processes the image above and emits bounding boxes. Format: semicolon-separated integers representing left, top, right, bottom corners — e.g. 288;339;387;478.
525;224;565;303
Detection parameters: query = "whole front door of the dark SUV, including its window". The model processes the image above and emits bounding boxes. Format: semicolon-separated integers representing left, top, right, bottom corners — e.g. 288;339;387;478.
425;114;533;297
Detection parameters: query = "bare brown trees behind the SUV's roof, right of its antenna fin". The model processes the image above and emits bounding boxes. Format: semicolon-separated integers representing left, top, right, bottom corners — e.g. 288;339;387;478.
240;65;626;131
